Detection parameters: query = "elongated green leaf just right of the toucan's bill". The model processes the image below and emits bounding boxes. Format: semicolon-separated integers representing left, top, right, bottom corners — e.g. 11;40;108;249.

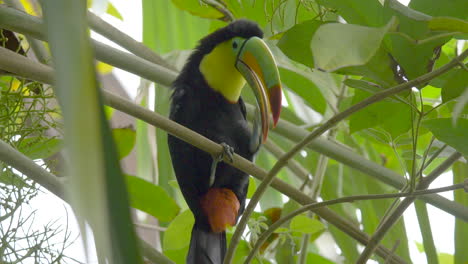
279;68;327;114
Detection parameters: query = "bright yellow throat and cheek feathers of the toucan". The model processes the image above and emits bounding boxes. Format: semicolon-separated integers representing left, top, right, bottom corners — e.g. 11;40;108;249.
200;40;245;103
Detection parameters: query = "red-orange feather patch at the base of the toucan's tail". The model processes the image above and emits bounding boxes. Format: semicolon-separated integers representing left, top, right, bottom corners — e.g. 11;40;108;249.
200;188;240;233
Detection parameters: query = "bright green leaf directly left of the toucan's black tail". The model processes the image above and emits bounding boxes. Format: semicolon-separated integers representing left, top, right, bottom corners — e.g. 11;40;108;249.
163;210;195;254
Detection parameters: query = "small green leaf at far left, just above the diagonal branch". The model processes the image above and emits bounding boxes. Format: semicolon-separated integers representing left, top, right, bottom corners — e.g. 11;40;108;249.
16;137;63;160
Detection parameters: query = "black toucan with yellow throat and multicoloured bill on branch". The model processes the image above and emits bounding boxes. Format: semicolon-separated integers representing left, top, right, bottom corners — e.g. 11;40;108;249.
168;20;282;264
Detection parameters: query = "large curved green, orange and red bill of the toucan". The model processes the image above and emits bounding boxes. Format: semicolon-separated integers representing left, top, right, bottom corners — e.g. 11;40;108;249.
236;37;281;146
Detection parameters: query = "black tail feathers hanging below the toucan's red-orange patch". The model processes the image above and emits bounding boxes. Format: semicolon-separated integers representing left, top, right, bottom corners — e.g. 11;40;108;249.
187;224;226;264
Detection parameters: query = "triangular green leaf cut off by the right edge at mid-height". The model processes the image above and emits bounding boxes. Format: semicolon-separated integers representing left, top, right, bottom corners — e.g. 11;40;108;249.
422;118;468;156
